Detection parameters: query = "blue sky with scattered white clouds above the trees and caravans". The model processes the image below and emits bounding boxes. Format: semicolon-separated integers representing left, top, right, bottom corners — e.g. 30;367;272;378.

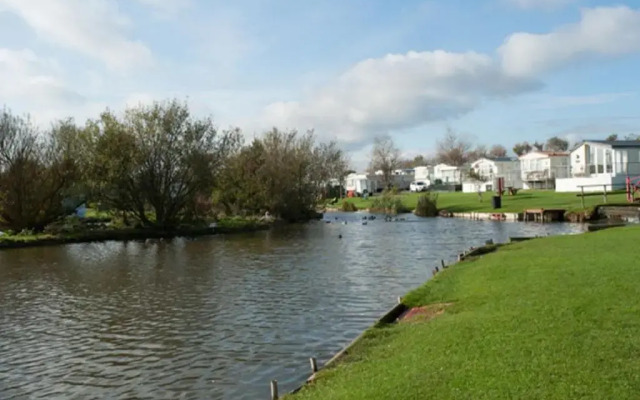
0;0;640;168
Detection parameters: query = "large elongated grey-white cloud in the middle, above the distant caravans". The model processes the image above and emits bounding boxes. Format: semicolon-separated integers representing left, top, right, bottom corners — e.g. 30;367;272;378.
265;51;539;145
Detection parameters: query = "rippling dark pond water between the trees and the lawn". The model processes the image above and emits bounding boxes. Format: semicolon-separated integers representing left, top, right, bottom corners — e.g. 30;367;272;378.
0;214;582;399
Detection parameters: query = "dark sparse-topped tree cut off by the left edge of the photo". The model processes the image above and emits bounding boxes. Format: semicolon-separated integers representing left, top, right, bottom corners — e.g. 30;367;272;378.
0;109;79;231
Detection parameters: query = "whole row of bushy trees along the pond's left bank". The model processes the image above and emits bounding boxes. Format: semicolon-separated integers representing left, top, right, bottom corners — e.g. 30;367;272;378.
0;100;348;231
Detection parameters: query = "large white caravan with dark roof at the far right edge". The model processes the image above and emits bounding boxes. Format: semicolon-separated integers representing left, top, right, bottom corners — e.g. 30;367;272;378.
556;140;640;192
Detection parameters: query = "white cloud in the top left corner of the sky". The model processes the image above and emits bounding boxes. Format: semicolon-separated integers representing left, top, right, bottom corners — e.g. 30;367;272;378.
0;0;152;70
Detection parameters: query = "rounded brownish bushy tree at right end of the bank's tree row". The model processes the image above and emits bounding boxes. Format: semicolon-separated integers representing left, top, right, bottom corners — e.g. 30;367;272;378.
214;128;348;221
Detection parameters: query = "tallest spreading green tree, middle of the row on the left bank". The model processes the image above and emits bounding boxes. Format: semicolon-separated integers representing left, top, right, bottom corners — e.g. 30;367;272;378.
87;100;240;228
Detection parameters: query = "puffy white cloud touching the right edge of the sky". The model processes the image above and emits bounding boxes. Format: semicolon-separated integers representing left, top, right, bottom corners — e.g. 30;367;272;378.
498;6;640;76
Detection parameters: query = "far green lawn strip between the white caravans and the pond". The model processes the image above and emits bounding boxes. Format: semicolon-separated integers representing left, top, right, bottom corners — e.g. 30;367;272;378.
348;190;626;212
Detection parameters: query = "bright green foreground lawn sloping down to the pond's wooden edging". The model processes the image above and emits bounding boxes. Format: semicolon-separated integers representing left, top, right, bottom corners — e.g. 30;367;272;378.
293;226;640;400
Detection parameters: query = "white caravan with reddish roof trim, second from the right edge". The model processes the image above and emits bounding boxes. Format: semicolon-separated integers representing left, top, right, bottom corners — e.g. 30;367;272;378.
519;150;569;189
